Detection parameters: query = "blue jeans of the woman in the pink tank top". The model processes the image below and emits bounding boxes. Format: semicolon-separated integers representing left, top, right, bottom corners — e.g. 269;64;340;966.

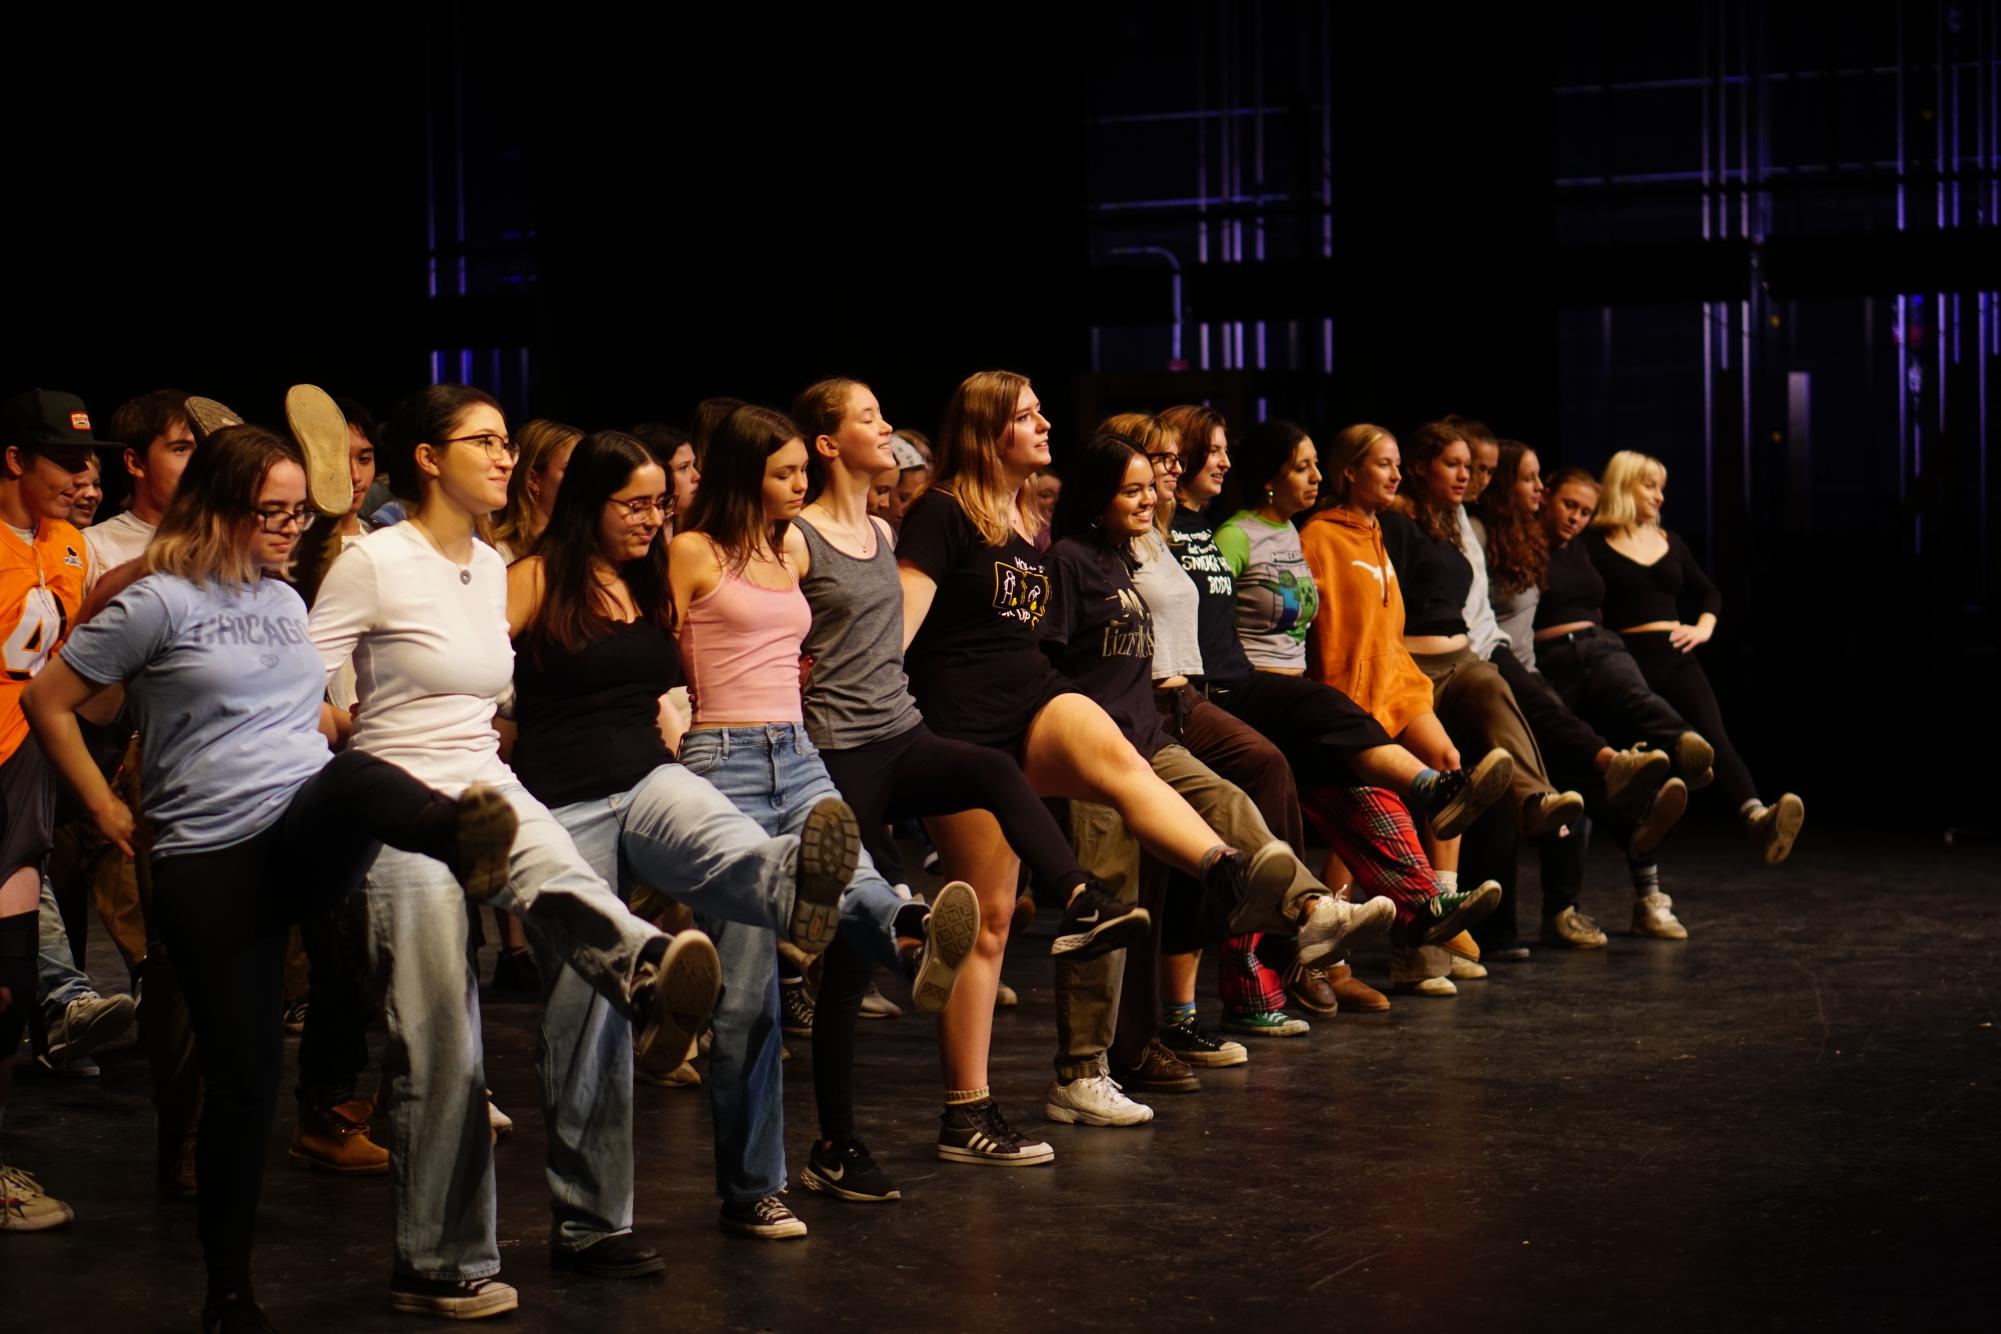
680;722;908;1204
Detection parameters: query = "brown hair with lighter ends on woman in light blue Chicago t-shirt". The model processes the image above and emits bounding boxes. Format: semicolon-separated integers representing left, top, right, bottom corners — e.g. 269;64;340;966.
144;426;300;588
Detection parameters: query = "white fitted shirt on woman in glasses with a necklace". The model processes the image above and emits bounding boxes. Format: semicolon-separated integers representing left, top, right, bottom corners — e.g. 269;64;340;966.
312;524;514;788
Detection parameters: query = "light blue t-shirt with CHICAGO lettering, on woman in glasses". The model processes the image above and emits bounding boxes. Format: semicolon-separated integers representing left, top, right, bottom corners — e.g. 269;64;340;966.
62;574;330;856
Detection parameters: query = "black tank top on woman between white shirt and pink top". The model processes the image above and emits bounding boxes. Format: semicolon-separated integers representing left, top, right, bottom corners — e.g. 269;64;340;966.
510;620;682;806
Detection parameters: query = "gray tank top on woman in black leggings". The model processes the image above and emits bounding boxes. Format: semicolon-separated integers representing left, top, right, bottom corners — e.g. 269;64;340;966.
796;520;922;750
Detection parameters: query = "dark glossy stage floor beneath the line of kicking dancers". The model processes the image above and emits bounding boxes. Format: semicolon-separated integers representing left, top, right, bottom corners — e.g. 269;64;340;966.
0;826;2001;1334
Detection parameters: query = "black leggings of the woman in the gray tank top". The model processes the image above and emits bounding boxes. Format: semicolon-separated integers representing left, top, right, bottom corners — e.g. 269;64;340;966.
812;722;1085;1140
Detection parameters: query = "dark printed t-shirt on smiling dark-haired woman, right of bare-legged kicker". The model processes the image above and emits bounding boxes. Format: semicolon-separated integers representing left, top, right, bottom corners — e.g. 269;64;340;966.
1037;538;1169;760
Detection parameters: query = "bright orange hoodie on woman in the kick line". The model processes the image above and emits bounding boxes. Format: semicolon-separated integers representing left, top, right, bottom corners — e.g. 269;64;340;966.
1299;506;1431;736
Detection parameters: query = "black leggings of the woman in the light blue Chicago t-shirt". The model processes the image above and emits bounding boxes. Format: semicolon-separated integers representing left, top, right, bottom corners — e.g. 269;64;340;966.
152;750;454;1294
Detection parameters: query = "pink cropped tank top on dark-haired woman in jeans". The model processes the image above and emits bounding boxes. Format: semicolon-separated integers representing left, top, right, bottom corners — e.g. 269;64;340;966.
680;570;812;724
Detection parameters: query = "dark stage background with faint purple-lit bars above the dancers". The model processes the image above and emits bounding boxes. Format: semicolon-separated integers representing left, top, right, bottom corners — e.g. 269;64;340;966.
0;0;2001;834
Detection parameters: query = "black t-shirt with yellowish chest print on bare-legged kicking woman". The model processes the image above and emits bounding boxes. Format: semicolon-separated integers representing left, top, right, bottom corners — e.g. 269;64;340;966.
896;490;1065;746
